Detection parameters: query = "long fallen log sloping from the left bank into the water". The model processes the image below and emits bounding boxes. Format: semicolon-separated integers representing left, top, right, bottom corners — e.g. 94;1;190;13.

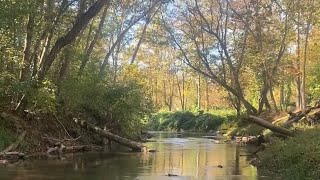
73;118;144;151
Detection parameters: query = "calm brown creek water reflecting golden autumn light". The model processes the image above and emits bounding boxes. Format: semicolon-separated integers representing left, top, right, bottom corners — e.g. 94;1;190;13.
0;133;271;180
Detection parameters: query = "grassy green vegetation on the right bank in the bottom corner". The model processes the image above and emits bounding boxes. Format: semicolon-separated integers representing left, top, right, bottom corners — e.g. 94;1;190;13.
259;129;320;180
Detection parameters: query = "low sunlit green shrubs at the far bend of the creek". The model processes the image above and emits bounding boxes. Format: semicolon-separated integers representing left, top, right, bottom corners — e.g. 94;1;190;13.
148;111;226;131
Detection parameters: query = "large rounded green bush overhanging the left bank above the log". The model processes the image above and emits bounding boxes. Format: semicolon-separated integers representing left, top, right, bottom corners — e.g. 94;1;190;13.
61;75;152;135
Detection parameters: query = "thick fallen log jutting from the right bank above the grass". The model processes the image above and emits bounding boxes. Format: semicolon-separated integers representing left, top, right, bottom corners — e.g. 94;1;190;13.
249;115;294;137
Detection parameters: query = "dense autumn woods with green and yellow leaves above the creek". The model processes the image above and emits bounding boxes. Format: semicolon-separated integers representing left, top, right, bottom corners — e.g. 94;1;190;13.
0;0;320;155
